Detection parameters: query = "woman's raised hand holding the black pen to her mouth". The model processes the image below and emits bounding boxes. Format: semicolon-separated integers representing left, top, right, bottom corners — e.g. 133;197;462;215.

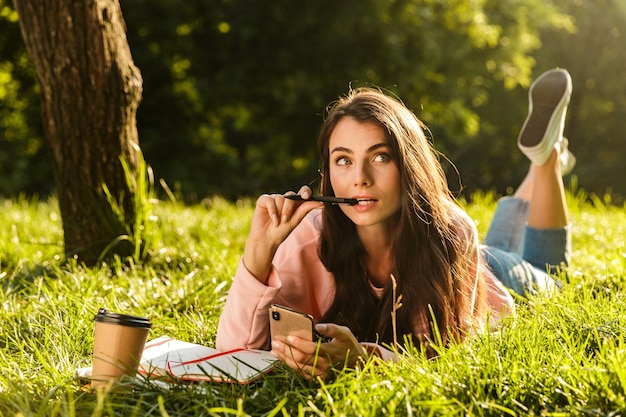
243;185;323;284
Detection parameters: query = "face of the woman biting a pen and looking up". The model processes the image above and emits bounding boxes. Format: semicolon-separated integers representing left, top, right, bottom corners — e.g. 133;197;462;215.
328;117;402;228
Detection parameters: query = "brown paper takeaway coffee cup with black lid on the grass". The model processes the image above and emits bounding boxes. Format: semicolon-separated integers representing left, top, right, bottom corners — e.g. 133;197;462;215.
91;308;152;388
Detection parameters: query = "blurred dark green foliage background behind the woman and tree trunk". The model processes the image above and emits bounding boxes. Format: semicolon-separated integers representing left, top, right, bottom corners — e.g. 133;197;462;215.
0;0;626;200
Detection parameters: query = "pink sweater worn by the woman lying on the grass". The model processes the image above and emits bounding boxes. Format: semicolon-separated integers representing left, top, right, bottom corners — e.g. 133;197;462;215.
216;210;513;358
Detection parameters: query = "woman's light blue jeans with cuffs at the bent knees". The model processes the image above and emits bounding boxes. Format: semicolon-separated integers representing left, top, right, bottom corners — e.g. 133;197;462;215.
481;197;571;296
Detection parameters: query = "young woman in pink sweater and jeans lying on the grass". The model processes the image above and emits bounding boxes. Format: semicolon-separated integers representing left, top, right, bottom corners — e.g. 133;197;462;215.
217;70;571;377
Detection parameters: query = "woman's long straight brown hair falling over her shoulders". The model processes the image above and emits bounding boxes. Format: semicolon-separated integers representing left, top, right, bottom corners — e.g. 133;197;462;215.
318;88;485;352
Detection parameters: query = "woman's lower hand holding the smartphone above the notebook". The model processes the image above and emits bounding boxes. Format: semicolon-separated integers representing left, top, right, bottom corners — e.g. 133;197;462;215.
272;324;366;379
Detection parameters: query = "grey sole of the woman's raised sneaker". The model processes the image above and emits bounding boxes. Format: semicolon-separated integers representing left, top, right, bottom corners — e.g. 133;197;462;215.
519;72;568;147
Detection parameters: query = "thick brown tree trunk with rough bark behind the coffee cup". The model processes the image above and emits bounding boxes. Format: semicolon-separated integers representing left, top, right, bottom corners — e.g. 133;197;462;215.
14;0;142;265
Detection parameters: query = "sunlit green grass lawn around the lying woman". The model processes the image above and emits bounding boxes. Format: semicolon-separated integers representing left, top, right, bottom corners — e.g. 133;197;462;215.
0;191;626;416
